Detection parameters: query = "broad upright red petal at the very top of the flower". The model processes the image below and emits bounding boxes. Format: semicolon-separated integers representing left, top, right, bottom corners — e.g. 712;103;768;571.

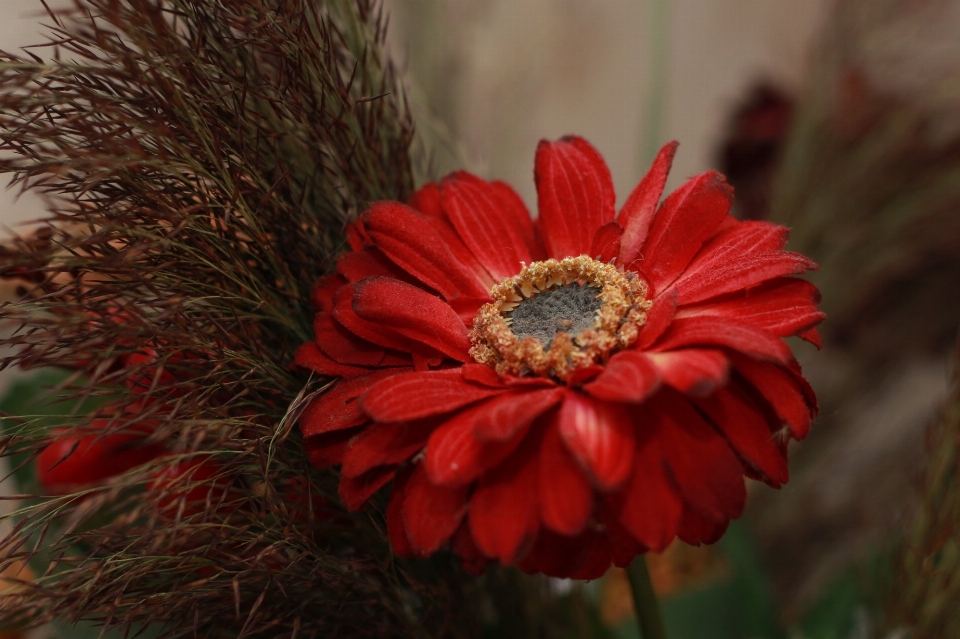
534;137;615;259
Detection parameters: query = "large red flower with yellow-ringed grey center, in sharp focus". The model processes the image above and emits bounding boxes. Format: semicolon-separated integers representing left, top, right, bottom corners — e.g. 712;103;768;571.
295;137;824;578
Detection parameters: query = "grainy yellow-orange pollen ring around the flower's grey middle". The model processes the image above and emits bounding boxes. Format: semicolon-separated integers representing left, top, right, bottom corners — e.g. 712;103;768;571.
470;255;653;381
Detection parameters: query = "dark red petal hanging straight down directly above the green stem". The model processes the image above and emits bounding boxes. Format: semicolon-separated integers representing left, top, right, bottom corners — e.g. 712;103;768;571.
619;437;683;552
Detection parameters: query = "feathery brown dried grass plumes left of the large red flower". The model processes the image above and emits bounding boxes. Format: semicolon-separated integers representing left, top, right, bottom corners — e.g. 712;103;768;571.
0;0;502;637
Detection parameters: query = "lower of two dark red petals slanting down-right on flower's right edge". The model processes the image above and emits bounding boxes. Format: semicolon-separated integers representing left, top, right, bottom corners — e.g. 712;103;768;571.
697;391;790;487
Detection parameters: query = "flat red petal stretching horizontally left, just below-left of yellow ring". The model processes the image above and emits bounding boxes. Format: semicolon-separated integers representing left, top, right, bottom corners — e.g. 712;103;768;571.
360;368;502;422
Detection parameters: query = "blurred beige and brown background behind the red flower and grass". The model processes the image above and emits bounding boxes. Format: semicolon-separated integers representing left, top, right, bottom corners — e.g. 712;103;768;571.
0;0;960;639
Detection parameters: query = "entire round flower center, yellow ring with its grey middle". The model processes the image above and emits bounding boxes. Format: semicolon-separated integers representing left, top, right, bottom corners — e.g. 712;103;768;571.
470;255;652;381
